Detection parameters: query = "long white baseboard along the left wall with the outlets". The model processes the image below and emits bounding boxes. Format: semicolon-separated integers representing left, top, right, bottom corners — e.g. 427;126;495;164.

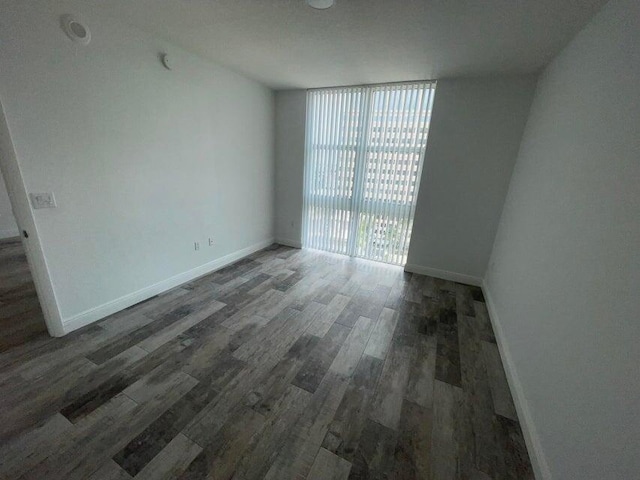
62;238;274;334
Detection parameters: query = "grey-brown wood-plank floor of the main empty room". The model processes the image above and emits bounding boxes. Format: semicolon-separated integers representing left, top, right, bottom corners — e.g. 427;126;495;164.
0;246;533;480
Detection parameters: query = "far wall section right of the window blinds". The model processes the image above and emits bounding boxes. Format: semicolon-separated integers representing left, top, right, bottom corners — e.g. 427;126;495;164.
406;76;536;284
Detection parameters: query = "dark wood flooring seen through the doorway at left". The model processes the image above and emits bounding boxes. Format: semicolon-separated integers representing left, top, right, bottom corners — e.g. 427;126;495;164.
0;237;47;352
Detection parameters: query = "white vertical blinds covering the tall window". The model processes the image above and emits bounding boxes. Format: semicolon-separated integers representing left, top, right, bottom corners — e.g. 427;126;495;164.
303;82;435;265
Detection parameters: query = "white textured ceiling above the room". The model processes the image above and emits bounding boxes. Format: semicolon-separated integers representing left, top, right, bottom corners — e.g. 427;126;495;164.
90;0;606;89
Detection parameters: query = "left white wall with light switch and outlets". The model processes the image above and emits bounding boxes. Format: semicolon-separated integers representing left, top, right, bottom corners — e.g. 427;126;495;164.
0;0;274;330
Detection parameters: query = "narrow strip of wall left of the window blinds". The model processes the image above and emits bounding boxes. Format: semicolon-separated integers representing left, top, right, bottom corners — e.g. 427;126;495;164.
275;90;307;247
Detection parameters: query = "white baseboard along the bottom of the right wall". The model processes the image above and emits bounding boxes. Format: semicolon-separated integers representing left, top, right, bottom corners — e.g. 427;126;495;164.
482;282;552;480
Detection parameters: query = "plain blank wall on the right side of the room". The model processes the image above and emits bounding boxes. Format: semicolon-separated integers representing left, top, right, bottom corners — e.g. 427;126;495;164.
486;0;640;480
